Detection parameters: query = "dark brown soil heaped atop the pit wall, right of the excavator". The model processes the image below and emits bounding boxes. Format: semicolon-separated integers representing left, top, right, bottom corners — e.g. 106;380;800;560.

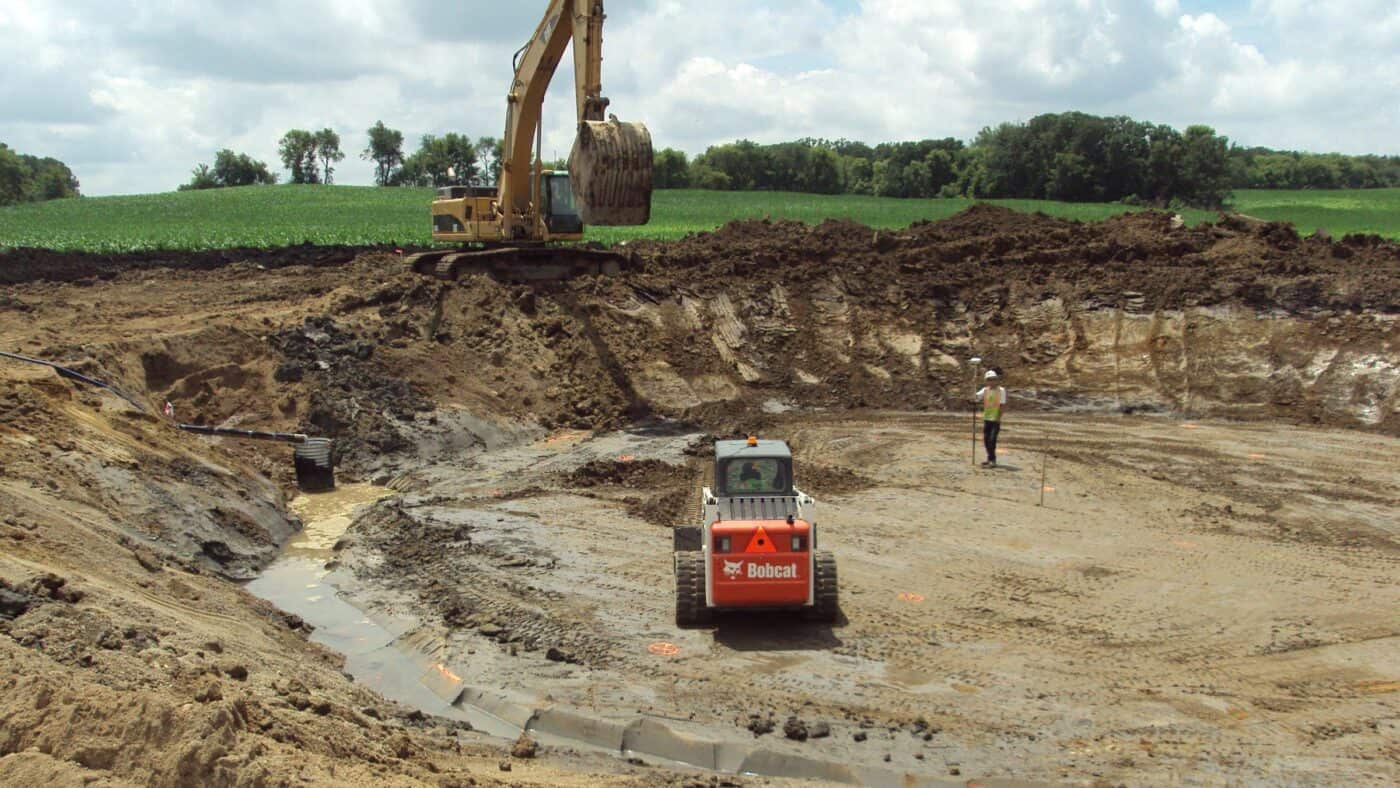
631;204;1400;314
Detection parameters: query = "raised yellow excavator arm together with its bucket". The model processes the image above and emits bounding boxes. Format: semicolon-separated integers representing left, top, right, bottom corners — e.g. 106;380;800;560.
498;0;652;238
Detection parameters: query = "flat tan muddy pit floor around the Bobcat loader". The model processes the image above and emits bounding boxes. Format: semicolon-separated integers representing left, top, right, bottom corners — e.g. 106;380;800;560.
322;413;1400;782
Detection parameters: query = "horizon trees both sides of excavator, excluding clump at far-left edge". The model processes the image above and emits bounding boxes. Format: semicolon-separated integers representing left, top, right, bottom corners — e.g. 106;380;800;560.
175;112;1400;209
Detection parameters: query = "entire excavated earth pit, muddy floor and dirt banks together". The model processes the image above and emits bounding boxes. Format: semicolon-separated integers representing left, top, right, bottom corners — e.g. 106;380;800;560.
0;209;1400;785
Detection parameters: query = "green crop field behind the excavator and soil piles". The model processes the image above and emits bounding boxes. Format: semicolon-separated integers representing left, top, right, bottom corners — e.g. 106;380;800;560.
0;186;1400;252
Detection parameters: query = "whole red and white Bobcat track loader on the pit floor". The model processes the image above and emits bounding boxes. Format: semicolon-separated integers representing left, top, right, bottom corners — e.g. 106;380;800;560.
675;438;837;627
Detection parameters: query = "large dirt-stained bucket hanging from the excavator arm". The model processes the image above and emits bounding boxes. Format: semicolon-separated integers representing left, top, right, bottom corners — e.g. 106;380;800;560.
568;118;652;225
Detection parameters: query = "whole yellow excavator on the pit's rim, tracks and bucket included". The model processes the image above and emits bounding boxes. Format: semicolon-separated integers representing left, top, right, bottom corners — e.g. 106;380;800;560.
409;0;652;280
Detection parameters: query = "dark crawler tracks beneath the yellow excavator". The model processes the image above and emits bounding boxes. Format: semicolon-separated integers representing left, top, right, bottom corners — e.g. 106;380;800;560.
407;246;633;283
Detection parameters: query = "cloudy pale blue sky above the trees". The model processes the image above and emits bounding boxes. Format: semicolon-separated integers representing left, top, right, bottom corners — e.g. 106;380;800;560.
0;0;1400;195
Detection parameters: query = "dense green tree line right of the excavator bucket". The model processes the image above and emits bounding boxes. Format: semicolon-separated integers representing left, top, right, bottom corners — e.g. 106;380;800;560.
654;112;1400;207
